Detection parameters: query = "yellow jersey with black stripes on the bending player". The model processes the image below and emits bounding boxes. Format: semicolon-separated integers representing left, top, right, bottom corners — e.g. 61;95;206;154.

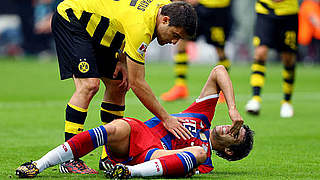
57;0;171;64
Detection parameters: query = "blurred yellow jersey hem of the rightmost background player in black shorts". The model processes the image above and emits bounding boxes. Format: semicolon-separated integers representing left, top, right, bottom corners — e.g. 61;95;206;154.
256;0;299;16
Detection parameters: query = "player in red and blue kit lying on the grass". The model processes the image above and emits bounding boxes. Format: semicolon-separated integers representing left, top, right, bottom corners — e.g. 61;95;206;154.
16;65;253;179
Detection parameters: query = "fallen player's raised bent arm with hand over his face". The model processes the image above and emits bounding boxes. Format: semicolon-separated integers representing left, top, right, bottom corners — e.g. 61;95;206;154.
199;65;243;135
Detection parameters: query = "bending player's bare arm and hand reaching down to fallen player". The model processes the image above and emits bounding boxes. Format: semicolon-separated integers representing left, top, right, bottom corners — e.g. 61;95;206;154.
127;57;192;139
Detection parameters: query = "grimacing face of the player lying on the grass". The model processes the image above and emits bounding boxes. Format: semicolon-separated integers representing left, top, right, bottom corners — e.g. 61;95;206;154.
211;125;246;148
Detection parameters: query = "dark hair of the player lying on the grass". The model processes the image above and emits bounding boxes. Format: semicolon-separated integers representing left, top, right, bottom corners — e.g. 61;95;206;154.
216;125;254;161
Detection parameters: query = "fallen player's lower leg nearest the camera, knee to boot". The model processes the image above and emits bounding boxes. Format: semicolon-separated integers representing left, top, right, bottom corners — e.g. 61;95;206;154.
107;146;207;179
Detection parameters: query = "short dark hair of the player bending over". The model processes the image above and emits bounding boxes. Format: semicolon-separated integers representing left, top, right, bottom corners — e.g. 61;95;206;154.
161;1;198;39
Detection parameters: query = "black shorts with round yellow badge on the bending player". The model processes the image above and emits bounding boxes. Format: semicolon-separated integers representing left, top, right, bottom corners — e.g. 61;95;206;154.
52;9;122;80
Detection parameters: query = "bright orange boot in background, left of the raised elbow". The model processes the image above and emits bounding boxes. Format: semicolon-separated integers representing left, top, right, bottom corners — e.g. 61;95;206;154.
160;85;189;101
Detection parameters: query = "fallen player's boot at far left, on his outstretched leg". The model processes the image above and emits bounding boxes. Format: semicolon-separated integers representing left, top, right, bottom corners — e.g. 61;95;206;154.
16;161;39;178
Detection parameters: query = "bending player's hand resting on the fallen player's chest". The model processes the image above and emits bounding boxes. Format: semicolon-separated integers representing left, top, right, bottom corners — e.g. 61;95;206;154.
163;116;192;140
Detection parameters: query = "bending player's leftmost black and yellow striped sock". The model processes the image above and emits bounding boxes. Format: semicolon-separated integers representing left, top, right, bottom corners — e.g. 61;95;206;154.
64;103;88;141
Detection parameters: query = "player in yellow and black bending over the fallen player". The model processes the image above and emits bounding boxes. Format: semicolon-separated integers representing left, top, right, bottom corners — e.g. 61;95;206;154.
52;0;197;174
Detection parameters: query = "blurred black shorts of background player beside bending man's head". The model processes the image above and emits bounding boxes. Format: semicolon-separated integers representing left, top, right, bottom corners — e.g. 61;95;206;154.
195;5;233;48
